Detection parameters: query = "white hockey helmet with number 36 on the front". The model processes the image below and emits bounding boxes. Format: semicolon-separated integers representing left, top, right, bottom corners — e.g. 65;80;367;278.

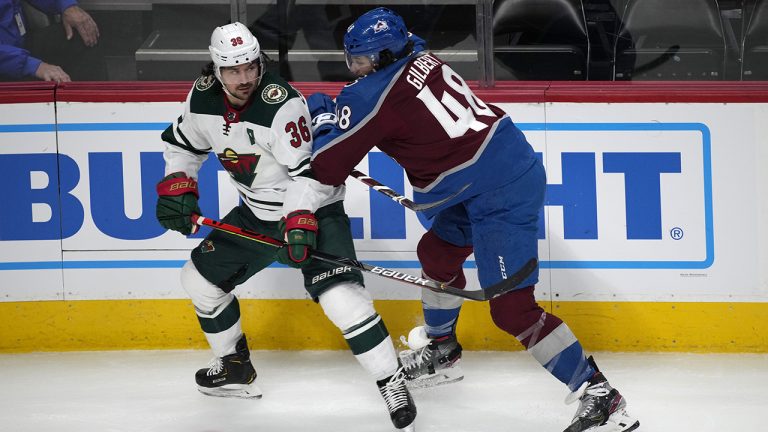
208;22;264;85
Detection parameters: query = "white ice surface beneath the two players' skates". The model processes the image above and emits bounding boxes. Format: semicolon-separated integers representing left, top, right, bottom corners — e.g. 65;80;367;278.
0;351;768;432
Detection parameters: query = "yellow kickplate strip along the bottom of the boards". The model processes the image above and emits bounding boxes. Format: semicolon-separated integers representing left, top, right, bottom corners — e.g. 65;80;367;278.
0;299;768;353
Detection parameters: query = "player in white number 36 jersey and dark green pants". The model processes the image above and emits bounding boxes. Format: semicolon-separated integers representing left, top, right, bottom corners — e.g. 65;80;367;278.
157;23;416;431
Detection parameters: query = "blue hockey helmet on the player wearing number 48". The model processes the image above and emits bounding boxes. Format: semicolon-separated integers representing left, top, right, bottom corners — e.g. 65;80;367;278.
344;7;408;67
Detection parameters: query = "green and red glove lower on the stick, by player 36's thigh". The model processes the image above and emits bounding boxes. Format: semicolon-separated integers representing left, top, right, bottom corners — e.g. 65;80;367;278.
277;210;317;268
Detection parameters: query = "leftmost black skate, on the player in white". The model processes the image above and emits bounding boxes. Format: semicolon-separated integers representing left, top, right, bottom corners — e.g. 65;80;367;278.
195;335;261;399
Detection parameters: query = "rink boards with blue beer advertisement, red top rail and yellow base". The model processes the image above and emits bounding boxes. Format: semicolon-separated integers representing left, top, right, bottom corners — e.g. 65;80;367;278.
0;83;768;352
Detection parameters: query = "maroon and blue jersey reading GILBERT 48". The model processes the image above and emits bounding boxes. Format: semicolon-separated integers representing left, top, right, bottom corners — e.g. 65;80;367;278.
312;52;533;218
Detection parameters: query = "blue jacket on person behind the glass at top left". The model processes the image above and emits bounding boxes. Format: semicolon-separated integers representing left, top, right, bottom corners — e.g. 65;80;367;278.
0;0;77;78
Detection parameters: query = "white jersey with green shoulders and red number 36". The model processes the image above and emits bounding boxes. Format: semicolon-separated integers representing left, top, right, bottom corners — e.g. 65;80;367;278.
162;72;344;221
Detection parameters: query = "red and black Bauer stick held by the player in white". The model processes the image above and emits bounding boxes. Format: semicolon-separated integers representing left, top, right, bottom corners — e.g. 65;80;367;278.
192;215;538;301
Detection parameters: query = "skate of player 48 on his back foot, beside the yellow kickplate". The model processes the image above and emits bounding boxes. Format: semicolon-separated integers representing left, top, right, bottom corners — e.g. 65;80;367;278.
399;327;464;389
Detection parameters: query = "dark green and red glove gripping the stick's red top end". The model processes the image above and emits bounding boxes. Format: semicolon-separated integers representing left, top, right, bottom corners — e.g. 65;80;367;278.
156;172;201;235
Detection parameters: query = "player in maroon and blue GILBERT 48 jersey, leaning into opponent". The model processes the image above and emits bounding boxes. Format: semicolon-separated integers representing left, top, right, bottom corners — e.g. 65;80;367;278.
309;8;640;432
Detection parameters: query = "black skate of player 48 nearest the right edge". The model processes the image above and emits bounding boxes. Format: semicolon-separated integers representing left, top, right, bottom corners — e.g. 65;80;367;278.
564;357;640;432
